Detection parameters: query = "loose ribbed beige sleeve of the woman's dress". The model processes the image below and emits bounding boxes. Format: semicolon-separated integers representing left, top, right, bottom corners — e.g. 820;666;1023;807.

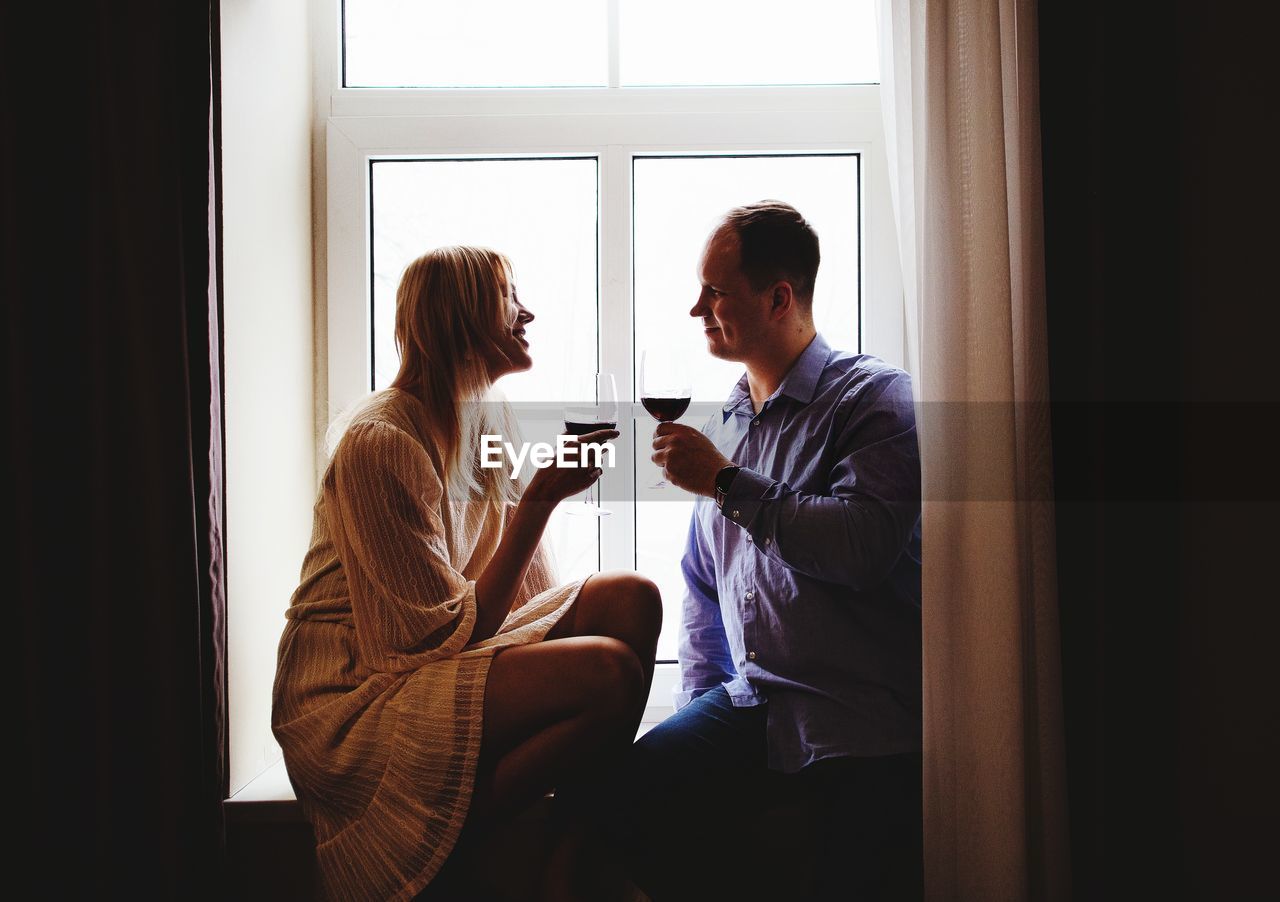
324;423;476;672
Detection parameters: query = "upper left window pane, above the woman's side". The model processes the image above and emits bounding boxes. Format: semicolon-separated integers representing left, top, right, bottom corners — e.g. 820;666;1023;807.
343;0;608;87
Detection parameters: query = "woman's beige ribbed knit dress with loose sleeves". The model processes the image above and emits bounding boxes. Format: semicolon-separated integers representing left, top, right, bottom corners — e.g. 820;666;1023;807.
271;389;582;899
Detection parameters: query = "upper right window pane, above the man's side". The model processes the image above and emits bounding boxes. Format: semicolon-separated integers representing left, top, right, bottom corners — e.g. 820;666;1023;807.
620;0;879;86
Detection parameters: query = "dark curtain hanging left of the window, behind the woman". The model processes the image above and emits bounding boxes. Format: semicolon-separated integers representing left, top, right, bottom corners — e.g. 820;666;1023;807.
0;0;228;898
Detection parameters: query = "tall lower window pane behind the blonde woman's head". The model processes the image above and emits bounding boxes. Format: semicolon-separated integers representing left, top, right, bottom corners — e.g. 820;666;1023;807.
371;157;599;580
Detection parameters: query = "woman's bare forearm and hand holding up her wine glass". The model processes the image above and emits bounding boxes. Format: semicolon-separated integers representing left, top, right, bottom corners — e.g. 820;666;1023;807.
471;430;618;642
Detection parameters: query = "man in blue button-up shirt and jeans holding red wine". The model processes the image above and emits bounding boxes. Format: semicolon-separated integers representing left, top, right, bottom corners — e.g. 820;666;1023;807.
586;201;920;899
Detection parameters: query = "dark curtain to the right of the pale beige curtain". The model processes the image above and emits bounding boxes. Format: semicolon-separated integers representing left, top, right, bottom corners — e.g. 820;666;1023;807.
1039;0;1280;899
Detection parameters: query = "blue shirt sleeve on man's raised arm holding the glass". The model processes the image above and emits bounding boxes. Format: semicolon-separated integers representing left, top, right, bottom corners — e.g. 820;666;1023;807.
721;370;920;591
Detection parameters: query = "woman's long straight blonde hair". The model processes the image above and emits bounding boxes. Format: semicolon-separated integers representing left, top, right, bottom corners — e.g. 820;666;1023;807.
329;246;524;504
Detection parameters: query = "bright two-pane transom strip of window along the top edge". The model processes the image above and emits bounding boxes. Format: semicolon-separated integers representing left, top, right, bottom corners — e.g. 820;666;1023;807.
340;0;879;88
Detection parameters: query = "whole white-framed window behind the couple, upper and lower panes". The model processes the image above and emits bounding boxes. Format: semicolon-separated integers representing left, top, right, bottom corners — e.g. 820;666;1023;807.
319;0;902;719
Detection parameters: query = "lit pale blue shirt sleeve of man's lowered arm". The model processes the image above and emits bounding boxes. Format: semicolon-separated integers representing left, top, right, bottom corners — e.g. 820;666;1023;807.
675;505;735;711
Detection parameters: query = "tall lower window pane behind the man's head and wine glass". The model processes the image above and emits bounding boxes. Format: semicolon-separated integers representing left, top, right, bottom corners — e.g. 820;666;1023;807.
634;154;860;658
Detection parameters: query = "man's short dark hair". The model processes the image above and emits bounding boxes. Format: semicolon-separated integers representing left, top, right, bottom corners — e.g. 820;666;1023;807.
717;201;822;306
